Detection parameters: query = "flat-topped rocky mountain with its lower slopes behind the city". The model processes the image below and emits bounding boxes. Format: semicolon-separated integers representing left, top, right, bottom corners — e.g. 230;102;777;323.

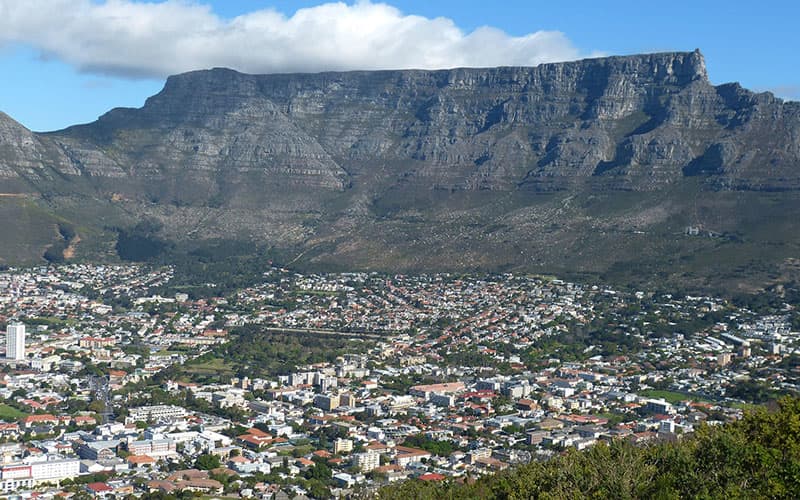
0;51;800;290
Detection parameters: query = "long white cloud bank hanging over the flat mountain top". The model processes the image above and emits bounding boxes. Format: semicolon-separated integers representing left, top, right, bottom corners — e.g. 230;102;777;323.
0;0;581;77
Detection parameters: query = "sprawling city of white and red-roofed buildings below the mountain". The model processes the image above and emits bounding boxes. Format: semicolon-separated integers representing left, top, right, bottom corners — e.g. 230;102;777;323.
0;266;800;498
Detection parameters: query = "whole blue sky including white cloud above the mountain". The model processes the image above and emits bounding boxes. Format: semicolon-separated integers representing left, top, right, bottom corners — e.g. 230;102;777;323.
0;0;800;130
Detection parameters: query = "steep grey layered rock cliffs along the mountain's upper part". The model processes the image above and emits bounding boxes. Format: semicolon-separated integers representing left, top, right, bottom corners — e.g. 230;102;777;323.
29;52;800;190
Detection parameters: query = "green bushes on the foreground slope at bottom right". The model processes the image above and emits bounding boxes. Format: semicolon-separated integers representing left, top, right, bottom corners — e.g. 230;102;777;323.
378;398;800;500
